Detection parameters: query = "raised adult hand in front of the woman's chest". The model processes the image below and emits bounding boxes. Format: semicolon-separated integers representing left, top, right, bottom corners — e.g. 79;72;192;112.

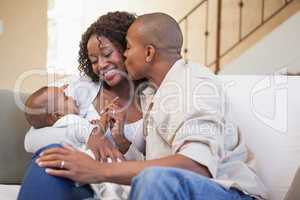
109;104;131;154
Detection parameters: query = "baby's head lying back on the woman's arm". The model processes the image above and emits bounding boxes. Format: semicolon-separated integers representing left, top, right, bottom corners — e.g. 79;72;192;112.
25;86;79;128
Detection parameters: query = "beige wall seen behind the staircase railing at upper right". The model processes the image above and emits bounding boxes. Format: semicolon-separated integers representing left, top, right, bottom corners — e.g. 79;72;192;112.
180;0;300;73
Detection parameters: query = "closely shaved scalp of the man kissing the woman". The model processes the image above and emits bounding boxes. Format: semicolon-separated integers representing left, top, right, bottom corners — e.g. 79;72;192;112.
133;13;183;54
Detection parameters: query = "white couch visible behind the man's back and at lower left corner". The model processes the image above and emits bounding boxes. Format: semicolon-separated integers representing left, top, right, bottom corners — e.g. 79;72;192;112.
0;75;300;200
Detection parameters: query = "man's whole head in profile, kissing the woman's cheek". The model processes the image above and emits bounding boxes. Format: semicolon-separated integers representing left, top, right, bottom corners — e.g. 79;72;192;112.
124;13;183;82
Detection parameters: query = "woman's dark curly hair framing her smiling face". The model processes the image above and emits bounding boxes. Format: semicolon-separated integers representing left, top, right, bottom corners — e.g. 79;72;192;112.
78;11;136;82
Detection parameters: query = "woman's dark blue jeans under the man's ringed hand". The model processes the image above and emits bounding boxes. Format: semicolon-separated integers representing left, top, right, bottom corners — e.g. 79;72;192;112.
18;144;94;200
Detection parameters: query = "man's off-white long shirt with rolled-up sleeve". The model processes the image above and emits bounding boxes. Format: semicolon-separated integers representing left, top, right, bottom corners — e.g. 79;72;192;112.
142;60;267;198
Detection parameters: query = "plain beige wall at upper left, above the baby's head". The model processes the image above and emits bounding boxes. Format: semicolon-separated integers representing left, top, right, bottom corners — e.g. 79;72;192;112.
0;0;47;91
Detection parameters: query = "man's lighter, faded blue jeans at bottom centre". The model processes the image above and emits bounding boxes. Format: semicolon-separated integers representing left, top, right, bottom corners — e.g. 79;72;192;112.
129;167;253;200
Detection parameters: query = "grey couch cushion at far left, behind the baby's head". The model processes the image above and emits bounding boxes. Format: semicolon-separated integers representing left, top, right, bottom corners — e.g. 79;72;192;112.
0;90;31;184
